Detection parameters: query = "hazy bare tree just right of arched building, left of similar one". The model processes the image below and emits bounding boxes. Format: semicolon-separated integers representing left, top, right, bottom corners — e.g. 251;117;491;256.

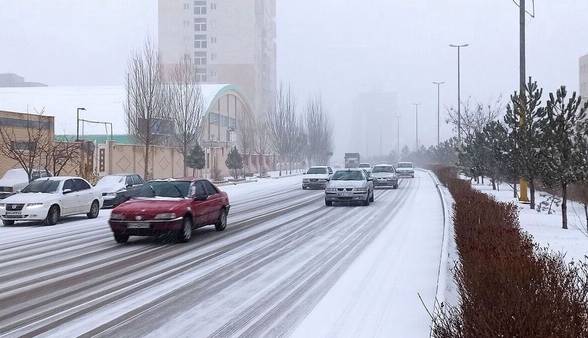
267;84;297;176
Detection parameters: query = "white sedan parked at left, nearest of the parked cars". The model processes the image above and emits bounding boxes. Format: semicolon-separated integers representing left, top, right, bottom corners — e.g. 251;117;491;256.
0;176;102;225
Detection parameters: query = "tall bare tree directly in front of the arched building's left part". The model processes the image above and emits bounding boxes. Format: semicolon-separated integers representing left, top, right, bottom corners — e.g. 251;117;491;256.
165;57;205;176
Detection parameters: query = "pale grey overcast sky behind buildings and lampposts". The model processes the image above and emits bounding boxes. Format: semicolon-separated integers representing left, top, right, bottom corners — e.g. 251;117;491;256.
0;0;588;158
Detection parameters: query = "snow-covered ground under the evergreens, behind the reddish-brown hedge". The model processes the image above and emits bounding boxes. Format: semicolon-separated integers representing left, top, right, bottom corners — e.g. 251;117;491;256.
473;183;588;261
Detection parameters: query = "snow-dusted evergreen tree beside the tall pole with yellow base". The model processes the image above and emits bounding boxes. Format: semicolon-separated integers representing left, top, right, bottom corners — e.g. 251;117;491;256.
504;78;545;209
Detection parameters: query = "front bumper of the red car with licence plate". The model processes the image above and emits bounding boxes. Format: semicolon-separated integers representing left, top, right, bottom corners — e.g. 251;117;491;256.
108;217;183;236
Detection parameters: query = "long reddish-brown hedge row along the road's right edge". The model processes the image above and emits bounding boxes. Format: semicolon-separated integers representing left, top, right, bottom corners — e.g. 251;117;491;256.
433;167;588;337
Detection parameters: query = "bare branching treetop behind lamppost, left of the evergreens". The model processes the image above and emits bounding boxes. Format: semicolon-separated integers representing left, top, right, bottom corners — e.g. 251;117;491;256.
445;96;504;139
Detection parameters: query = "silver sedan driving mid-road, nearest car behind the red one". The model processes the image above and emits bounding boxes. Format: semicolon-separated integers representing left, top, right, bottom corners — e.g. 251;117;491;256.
325;168;374;207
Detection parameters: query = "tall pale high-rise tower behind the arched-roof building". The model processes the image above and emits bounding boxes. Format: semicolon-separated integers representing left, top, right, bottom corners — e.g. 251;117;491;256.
158;0;276;114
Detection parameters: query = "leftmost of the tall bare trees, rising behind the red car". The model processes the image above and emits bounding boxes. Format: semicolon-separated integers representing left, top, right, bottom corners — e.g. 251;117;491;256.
125;41;164;178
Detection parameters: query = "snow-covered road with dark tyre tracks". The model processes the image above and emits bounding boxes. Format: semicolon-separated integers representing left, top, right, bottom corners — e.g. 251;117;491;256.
0;172;443;337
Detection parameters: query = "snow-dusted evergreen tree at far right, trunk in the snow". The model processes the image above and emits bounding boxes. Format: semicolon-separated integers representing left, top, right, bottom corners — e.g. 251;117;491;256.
542;86;588;229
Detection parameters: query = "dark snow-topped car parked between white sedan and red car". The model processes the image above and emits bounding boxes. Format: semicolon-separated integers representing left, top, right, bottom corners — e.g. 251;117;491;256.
96;174;145;208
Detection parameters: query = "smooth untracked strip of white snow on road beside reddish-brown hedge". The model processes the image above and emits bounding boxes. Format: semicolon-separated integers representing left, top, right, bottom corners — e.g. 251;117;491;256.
293;172;443;337
